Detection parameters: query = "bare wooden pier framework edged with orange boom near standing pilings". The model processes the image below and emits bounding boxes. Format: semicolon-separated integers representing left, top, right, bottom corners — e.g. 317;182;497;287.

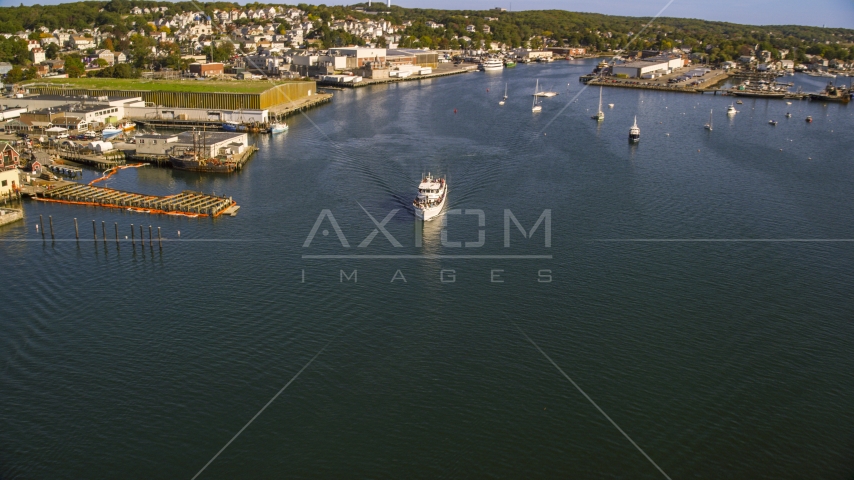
35;183;237;217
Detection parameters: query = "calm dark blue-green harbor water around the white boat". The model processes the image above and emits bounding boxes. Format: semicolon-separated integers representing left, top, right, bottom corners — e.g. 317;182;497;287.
0;61;854;479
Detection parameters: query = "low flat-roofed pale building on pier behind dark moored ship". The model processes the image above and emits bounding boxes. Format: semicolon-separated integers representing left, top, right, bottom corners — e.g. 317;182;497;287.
134;131;249;157
